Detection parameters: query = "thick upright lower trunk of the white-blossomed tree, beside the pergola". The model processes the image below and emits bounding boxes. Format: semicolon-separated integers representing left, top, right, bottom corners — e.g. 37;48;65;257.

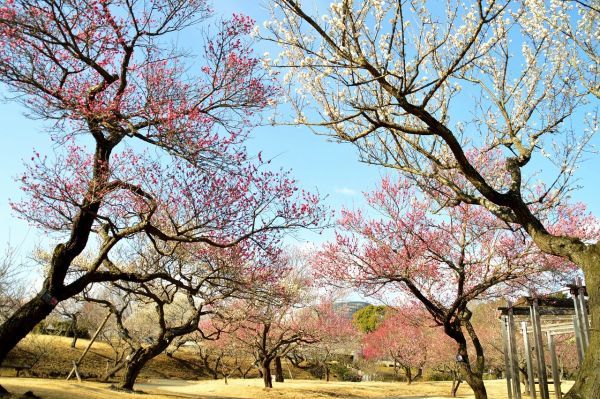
564;252;600;399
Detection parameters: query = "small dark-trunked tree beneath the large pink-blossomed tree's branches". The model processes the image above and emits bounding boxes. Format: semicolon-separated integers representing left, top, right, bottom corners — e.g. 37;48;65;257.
85;245;250;390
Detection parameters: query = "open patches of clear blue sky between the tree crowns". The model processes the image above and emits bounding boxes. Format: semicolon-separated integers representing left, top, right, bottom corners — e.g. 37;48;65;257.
0;0;600;288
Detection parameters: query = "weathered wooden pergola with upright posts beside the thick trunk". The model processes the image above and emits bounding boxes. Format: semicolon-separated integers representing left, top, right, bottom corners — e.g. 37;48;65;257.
498;280;590;399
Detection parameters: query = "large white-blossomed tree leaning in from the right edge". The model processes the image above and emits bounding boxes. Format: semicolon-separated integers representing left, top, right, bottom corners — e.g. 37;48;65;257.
266;0;600;398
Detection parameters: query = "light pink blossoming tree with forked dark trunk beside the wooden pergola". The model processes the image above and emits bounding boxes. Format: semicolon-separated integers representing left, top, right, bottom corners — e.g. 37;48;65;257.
314;178;596;398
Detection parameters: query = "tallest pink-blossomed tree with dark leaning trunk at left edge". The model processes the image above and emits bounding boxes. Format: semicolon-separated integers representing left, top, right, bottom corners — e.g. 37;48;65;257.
0;0;322;390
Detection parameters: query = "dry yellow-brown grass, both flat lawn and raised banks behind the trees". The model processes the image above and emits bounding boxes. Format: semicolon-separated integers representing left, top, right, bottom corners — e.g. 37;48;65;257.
0;335;570;399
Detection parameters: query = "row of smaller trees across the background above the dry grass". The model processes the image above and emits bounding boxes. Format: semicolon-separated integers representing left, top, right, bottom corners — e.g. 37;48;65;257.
1;245;576;395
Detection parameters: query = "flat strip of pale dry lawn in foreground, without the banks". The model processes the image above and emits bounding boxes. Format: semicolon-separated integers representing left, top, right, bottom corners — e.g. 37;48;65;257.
0;378;570;399
